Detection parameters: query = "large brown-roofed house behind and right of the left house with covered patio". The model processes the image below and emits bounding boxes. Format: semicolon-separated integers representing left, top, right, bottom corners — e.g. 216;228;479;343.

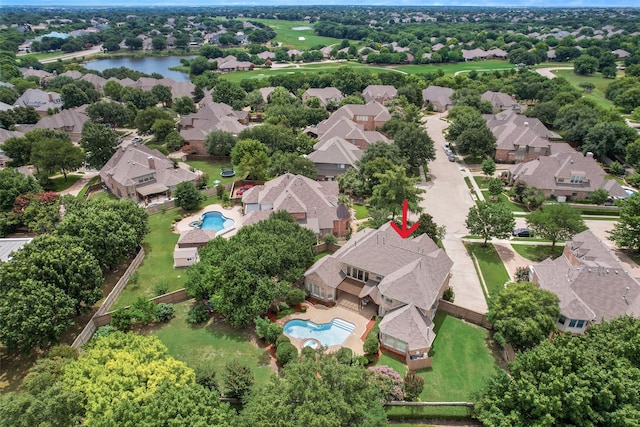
178;102;249;154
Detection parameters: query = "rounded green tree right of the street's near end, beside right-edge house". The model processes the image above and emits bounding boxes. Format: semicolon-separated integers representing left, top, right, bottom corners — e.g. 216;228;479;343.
487;282;560;350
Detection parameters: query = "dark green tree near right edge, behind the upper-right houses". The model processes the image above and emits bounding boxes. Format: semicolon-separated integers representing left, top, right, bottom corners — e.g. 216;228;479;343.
581;121;638;159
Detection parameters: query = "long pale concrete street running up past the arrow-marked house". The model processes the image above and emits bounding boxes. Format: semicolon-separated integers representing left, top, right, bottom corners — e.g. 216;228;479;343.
419;114;487;313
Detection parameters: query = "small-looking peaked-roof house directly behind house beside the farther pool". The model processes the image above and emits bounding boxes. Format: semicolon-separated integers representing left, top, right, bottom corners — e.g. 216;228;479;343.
307;136;362;181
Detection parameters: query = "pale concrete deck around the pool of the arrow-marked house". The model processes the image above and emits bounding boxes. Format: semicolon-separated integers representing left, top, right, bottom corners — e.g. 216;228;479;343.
277;304;371;355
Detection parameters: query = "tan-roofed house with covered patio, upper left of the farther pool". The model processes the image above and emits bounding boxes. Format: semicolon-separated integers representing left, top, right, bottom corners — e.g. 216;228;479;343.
100;144;198;201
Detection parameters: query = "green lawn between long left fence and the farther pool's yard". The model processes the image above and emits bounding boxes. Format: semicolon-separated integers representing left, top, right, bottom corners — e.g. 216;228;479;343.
113;208;187;309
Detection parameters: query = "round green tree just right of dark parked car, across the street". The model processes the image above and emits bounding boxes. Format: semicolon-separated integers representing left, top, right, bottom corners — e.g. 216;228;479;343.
526;203;587;248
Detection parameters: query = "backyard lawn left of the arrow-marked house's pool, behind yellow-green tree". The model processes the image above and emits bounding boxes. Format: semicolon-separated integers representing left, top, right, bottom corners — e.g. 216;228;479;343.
150;301;274;385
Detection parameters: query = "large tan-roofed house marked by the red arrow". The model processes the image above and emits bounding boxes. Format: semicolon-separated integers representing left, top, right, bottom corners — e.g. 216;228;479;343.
304;224;453;369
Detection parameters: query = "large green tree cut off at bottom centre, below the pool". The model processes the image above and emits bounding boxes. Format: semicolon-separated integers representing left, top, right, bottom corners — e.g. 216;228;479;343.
239;356;387;427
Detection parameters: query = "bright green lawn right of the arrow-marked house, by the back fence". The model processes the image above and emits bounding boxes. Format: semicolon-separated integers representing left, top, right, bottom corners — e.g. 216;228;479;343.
377;312;497;416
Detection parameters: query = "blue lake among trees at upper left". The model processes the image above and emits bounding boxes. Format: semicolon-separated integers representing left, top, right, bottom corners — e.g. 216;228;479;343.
83;56;195;82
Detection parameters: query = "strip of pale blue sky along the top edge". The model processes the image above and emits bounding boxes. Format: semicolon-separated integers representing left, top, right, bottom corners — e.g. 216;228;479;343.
0;0;638;8
